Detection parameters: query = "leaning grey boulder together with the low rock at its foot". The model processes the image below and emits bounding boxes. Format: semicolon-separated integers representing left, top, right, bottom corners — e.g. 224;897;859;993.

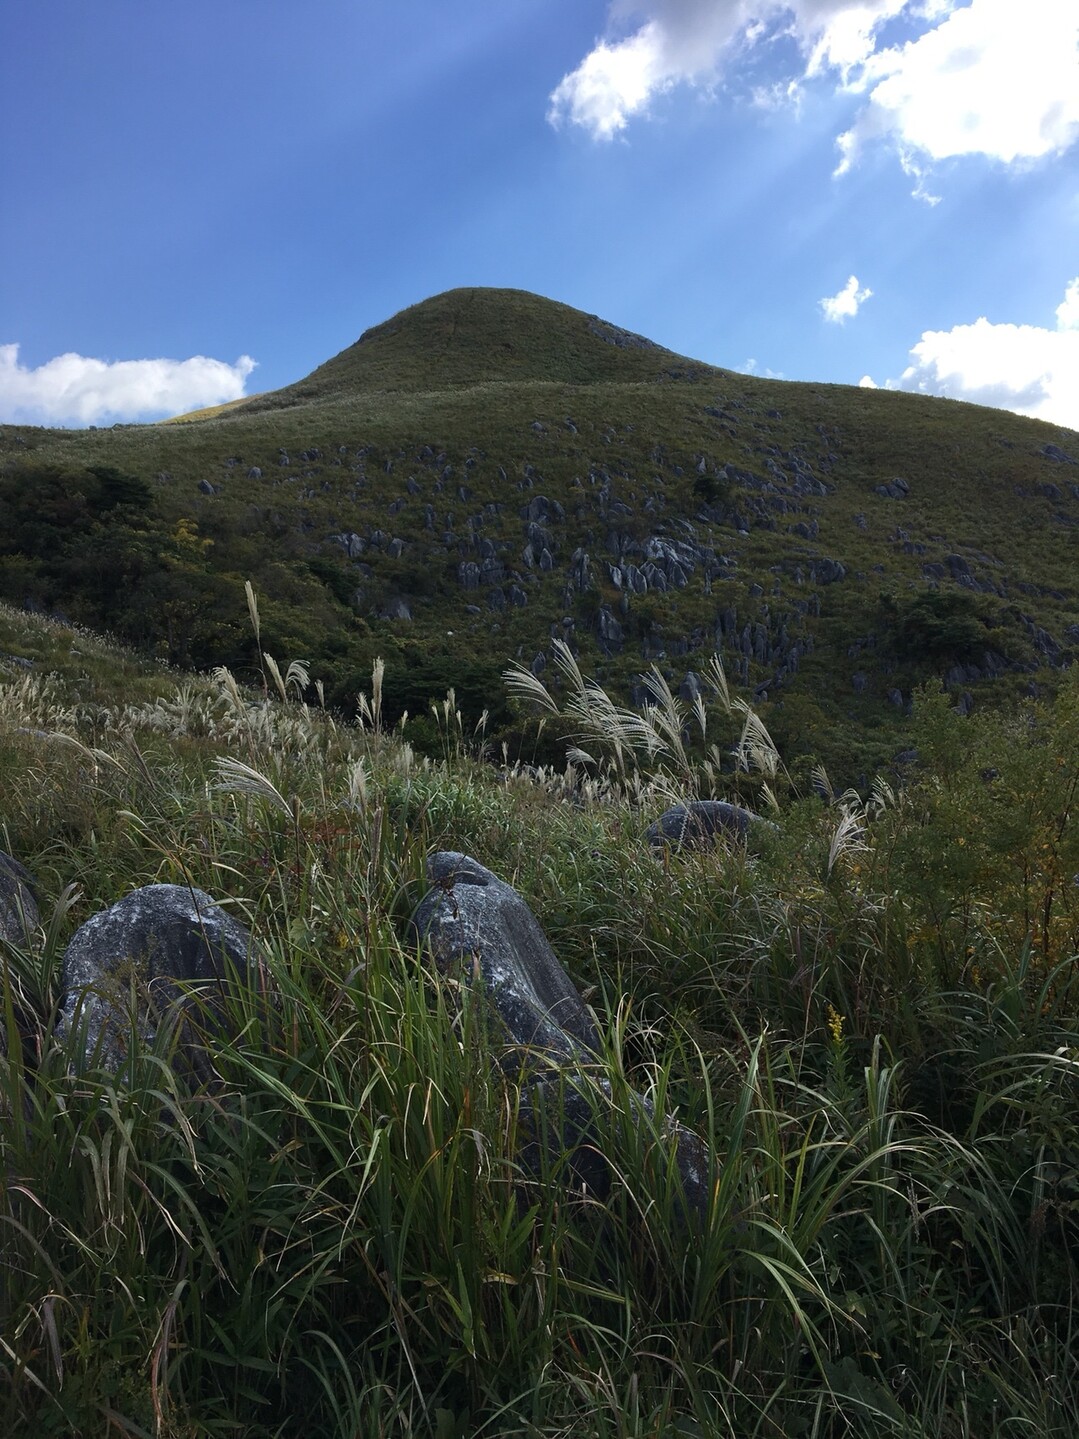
411;852;709;1217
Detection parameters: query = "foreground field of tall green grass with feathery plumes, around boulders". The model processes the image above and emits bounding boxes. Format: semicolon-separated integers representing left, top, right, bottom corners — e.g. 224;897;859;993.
0;606;1079;1439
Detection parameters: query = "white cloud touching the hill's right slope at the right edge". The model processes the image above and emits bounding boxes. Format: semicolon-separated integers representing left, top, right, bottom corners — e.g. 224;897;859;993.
886;276;1079;430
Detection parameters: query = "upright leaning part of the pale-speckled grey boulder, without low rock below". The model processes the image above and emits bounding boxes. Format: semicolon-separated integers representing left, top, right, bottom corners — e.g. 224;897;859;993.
411;850;600;1062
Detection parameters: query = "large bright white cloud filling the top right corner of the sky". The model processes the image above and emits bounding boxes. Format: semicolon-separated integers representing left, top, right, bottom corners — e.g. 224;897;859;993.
548;0;1079;188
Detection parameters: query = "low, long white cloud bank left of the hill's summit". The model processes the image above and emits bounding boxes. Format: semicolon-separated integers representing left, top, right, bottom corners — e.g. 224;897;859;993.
0;345;255;426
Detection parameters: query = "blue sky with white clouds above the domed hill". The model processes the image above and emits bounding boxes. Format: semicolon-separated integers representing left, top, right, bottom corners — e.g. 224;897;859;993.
0;0;1079;429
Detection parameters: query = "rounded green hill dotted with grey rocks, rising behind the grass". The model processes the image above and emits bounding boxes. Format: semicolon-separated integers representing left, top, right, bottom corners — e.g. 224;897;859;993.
0;289;1079;784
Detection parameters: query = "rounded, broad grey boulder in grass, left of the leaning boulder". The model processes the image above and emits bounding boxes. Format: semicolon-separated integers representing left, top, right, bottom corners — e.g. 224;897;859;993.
58;885;258;1078
